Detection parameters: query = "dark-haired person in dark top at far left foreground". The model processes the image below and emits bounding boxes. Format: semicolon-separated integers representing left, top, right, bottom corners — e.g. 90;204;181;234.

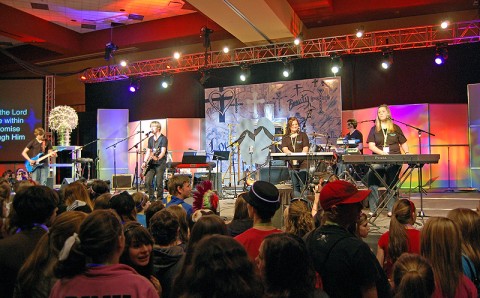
0;186;58;297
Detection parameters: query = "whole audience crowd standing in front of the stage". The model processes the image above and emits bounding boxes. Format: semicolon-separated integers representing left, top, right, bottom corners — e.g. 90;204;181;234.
0;175;480;298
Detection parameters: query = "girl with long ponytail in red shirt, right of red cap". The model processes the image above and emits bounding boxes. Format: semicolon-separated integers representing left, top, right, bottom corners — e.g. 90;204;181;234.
377;199;420;278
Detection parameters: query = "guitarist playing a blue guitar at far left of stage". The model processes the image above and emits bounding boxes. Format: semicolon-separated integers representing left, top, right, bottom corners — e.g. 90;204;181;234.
22;127;57;185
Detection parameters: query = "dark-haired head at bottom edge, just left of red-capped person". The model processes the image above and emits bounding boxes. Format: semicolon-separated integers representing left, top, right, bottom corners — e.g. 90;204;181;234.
255;233;327;298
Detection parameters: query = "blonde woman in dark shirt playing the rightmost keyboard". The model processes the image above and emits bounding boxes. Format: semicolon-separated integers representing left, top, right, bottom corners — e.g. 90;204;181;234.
367;105;409;217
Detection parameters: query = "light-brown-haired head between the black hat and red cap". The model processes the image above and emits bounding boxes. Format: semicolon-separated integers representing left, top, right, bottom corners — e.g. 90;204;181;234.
283;199;315;238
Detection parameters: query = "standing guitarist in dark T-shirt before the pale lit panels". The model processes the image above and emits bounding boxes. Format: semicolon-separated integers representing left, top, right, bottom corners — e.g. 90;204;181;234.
142;121;168;200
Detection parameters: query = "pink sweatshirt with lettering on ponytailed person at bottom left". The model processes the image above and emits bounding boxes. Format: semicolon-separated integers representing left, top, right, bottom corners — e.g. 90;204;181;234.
50;264;158;298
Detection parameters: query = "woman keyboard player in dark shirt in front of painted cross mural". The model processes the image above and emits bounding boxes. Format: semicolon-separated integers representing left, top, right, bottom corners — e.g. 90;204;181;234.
281;117;310;198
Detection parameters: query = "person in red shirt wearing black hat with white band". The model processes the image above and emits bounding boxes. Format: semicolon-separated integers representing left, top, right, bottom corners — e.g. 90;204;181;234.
235;181;282;260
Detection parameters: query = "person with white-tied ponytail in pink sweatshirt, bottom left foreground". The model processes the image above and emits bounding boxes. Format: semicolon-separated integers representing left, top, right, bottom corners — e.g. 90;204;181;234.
50;210;159;298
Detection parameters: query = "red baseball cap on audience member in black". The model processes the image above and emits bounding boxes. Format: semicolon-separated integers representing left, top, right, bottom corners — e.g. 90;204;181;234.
320;180;371;210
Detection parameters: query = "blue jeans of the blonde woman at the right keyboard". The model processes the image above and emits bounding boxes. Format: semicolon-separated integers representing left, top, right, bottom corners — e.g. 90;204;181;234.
367;164;401;212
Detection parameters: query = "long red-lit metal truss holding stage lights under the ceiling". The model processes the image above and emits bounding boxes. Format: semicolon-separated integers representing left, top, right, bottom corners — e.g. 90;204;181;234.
82;20;480;83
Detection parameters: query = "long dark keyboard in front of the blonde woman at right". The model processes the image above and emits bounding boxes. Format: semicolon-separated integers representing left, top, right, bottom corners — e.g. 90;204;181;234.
342;154;440;165
